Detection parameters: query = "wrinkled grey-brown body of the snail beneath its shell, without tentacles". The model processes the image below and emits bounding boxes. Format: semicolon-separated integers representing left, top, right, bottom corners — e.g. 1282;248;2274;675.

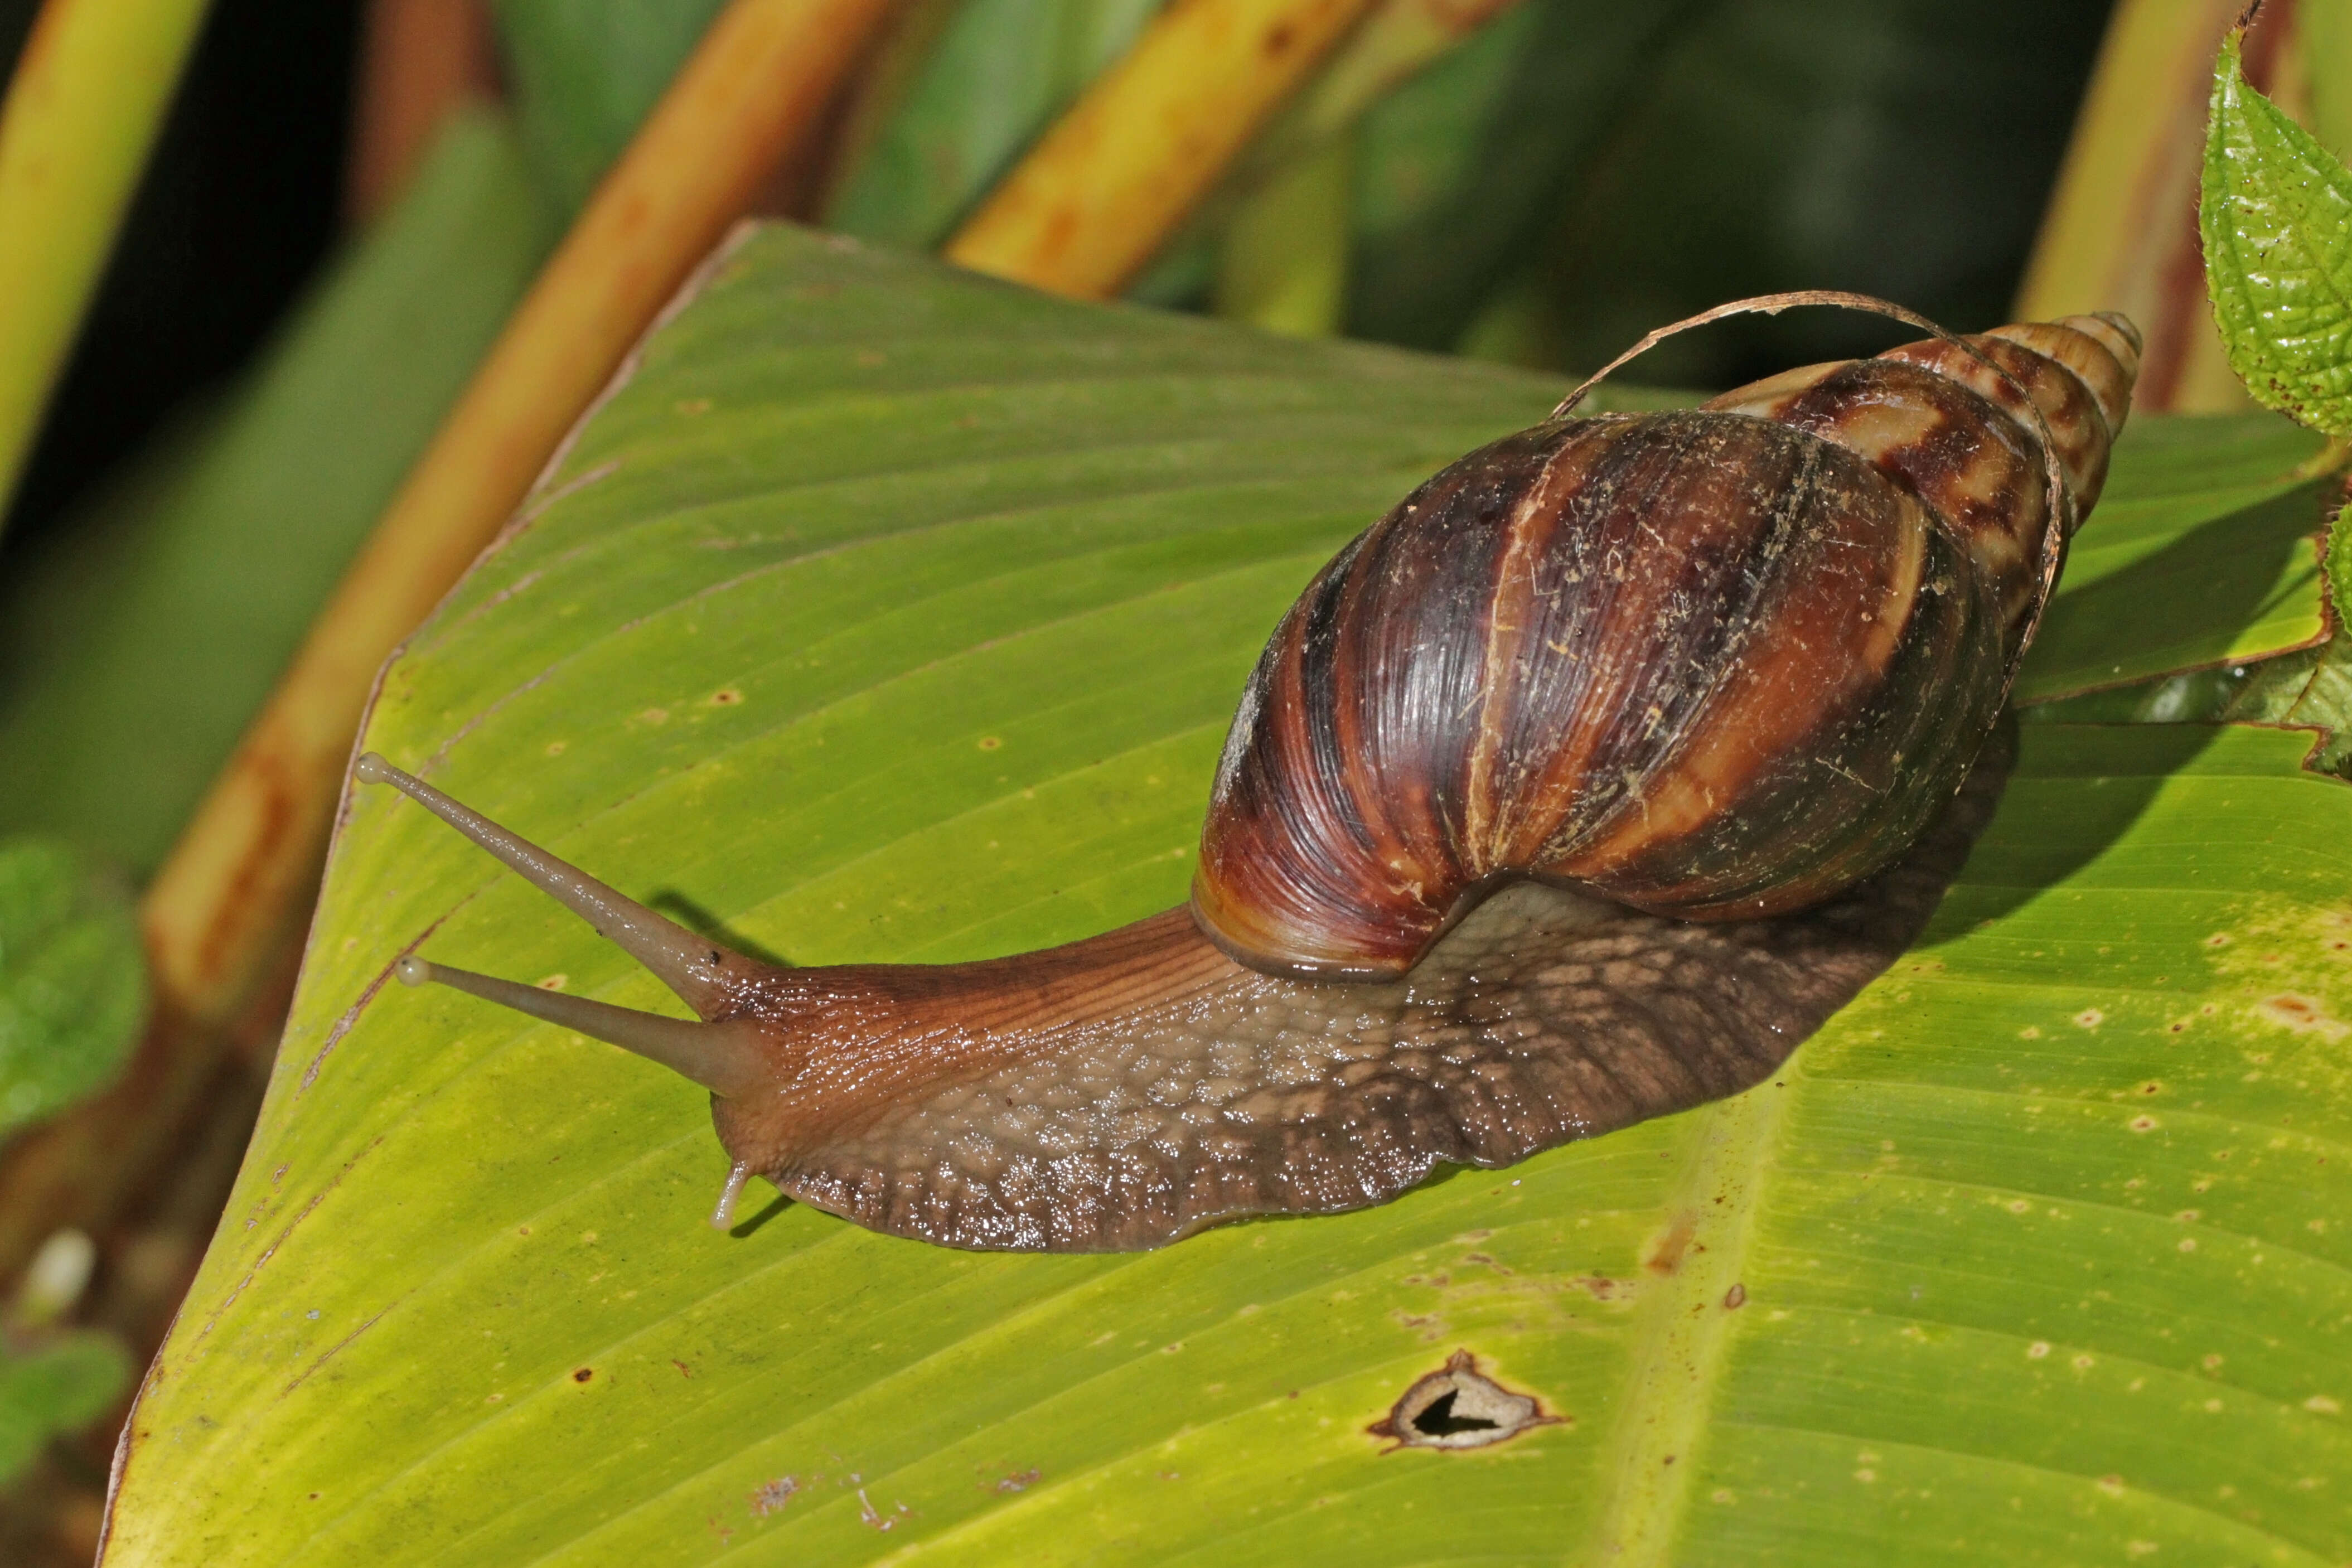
713;724;2009;1251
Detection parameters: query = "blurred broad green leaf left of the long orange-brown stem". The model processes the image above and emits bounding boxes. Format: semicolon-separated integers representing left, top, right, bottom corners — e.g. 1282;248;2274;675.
0;113;553;870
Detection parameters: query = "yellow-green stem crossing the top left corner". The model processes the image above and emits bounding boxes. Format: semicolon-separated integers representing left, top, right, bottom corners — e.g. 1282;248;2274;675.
0;0;205;531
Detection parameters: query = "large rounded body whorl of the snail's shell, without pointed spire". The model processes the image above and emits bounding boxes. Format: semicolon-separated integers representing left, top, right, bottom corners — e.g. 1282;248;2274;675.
1195;412;1999;973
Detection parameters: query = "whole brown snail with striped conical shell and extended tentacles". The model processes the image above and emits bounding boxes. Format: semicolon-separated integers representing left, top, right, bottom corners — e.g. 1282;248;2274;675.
355;294;2138;1251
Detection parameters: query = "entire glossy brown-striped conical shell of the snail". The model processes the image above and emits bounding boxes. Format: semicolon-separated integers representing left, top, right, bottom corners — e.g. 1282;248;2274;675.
1193;315;2138;976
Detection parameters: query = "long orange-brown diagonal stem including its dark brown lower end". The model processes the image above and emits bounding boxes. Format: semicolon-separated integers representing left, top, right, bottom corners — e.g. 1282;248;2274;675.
0;0;887;1335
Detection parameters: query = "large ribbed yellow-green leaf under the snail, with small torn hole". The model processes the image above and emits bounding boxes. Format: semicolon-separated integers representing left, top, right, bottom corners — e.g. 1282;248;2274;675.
106;228;2352;1568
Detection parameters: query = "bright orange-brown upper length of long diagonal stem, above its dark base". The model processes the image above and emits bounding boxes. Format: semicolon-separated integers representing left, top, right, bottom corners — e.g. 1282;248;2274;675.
146;0;887;1015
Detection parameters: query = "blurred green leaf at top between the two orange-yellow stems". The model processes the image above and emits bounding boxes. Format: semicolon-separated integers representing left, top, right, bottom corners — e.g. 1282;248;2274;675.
826;0;1159;249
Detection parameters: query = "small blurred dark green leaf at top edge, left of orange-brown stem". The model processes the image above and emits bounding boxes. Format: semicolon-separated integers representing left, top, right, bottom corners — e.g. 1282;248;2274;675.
492;0;724;216
